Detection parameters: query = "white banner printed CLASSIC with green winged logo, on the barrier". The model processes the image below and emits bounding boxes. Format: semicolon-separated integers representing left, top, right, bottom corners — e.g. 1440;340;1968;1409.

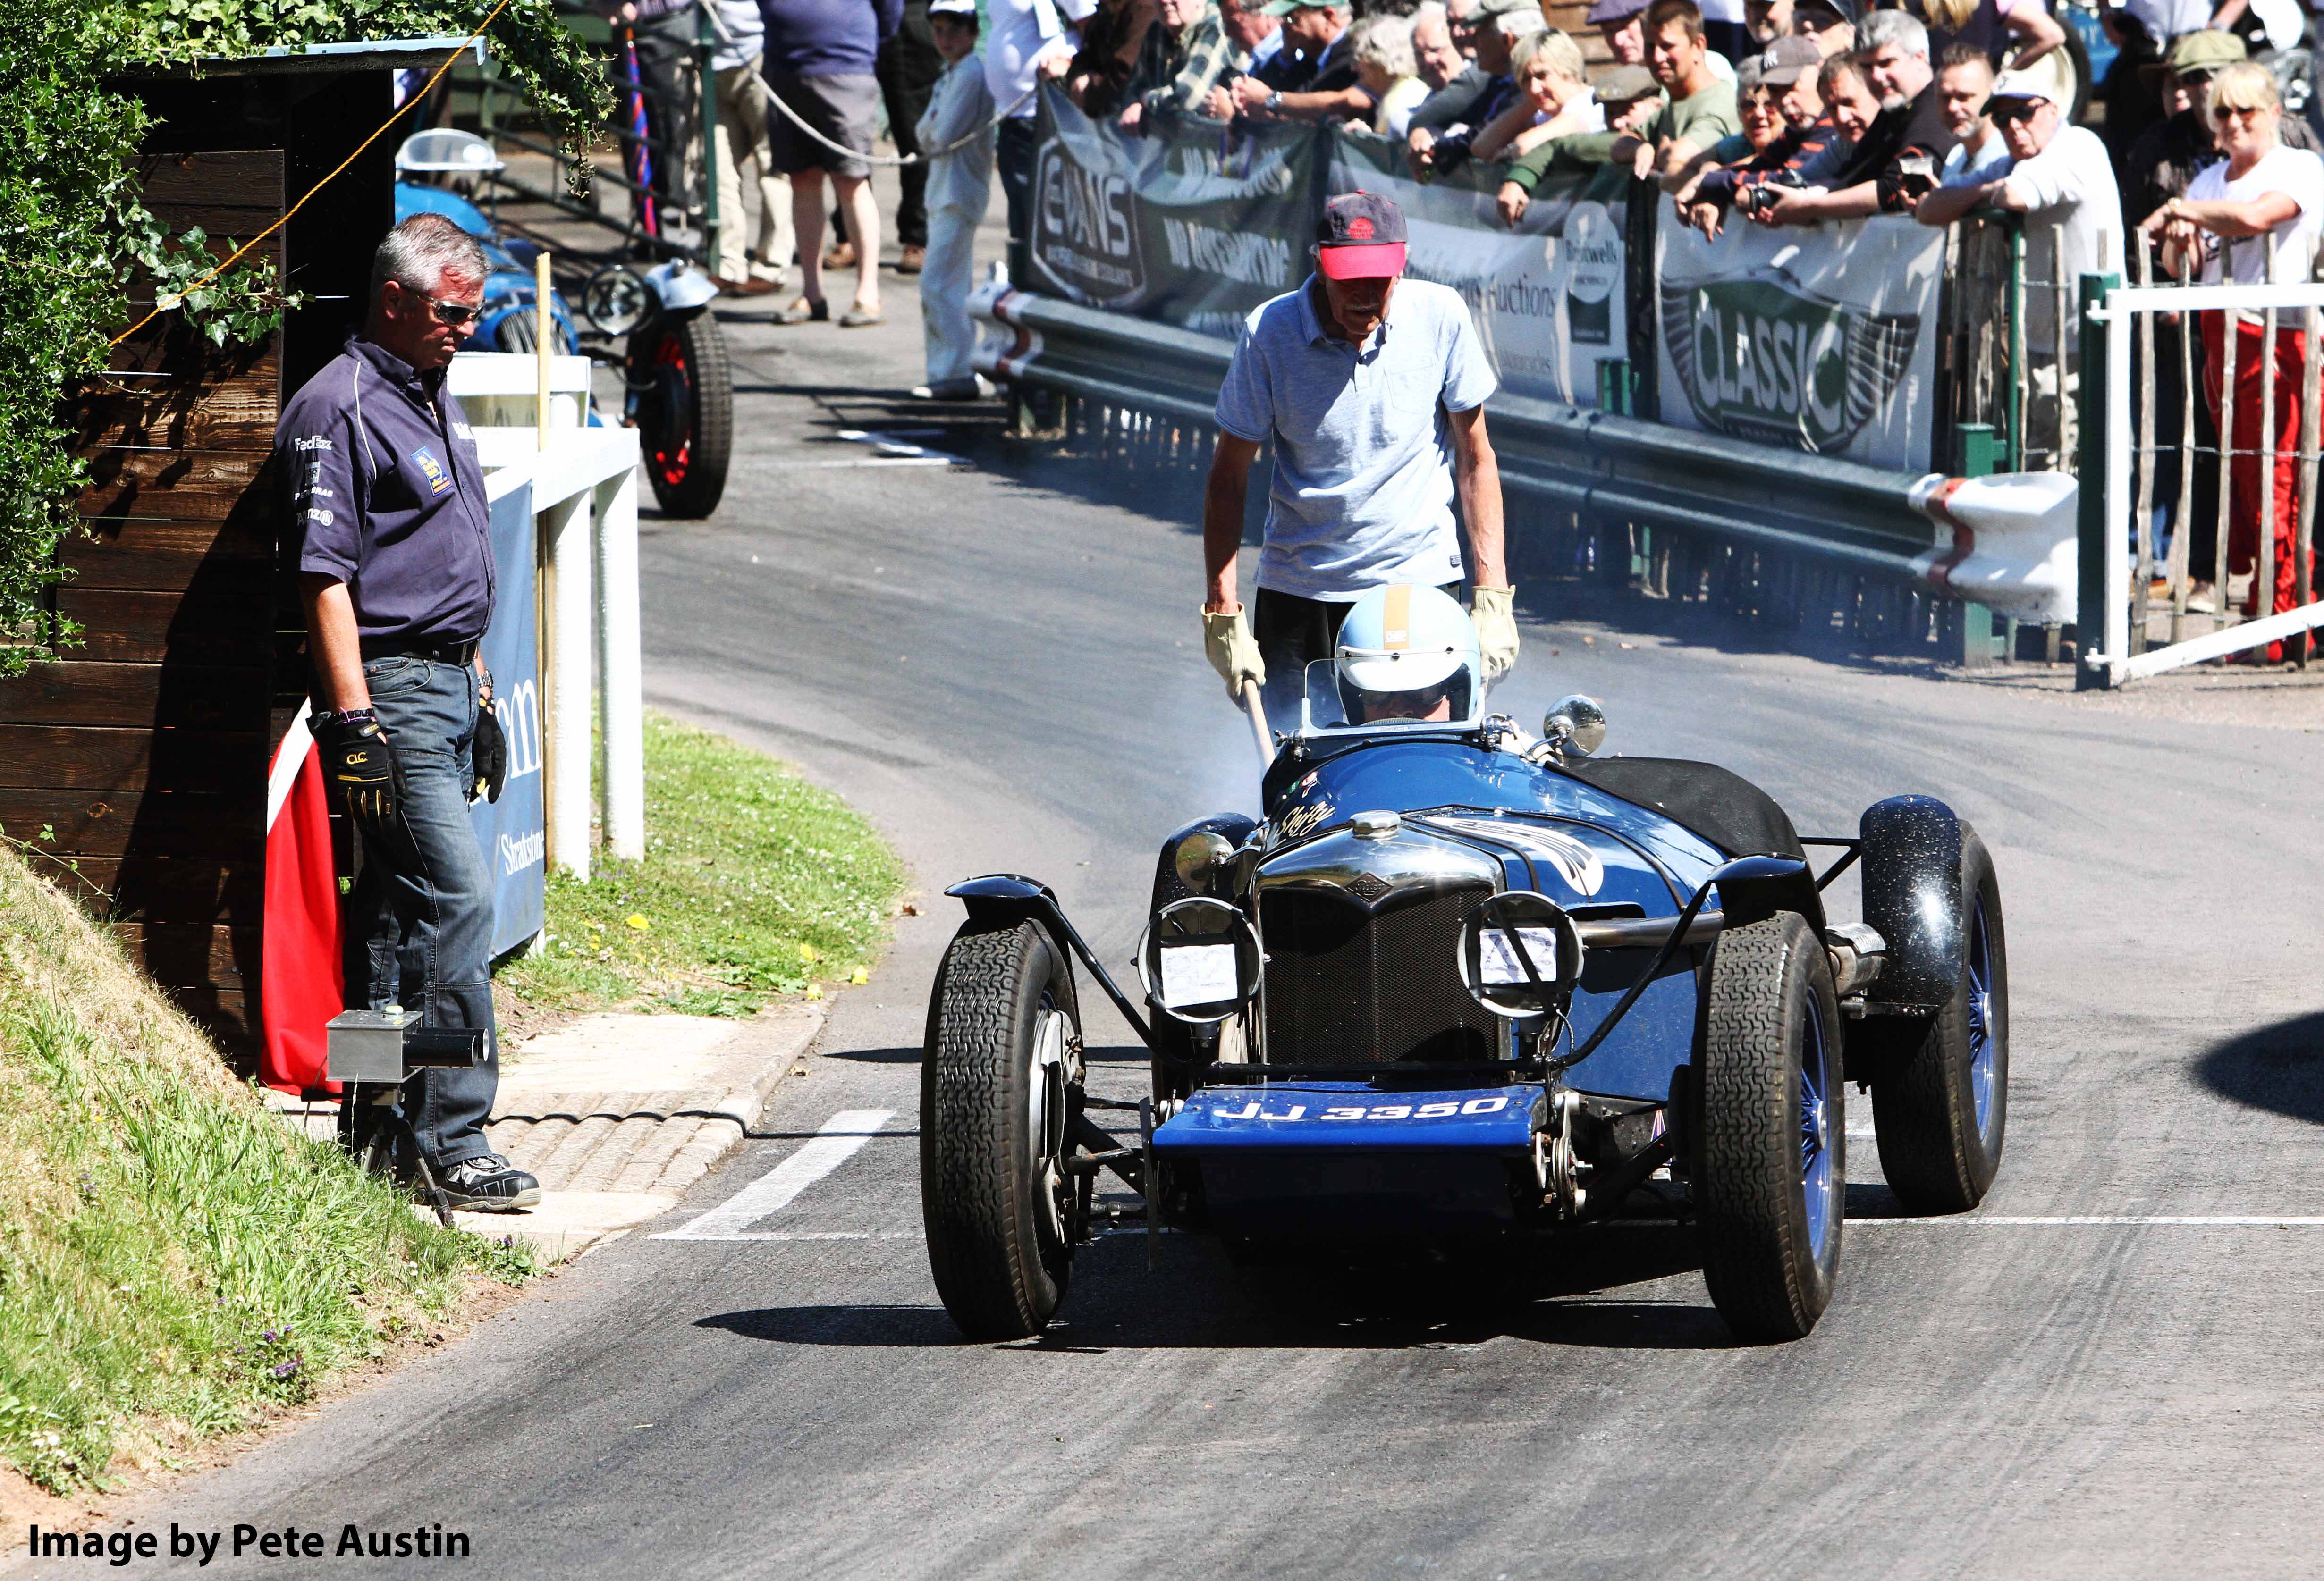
1657;200;1945;472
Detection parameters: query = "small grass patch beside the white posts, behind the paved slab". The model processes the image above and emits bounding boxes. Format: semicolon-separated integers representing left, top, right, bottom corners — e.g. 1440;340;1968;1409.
495;714;904;1016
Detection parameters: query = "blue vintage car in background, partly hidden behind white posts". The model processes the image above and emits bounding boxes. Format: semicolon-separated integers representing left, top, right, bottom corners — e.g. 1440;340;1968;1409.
395;128;735;519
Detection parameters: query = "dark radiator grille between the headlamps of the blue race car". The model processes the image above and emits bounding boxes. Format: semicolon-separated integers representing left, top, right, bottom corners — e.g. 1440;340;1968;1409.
1259;883;1501;1065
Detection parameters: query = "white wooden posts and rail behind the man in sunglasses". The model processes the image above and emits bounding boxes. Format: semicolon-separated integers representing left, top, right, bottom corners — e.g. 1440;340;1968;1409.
448;351;646;879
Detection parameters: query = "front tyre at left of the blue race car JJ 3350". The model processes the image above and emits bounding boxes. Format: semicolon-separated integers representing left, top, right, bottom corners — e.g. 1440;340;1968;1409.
921;921;1081;1339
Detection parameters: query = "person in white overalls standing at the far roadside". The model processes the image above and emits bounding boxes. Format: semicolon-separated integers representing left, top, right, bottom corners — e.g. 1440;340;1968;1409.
913;0;992;400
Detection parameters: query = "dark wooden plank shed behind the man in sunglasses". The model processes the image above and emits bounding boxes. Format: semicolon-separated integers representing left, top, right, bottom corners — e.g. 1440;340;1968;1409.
0;40;472;1060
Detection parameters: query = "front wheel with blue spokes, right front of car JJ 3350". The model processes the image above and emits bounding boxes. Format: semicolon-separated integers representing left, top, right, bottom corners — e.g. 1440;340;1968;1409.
1690;911;1848;1342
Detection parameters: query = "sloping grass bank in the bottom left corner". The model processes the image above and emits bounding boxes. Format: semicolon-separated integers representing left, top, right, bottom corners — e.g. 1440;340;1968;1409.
0;844;532;1493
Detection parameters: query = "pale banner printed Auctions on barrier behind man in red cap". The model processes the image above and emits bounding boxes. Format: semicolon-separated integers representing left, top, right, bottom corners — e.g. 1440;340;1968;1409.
1327;130;1629;407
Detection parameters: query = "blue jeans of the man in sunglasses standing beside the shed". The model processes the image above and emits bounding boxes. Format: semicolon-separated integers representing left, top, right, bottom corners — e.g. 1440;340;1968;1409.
346;653;499;1169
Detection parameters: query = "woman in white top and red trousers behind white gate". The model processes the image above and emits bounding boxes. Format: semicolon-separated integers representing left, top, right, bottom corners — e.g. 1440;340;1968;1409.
2145;60;2324;641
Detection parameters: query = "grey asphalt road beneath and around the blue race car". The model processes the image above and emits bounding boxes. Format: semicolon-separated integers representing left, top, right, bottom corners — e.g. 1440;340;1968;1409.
109;229;2324;1581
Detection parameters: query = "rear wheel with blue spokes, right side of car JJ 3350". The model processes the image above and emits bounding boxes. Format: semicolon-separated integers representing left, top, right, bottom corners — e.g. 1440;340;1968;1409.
1873;825;2010;1214
